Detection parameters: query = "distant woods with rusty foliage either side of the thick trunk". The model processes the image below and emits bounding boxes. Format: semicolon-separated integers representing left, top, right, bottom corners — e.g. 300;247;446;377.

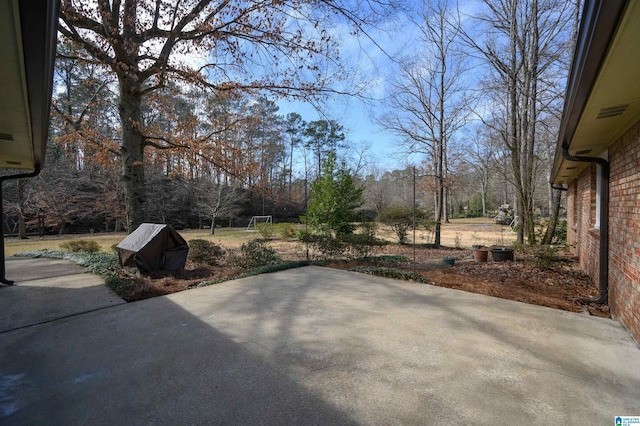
4;77;347;237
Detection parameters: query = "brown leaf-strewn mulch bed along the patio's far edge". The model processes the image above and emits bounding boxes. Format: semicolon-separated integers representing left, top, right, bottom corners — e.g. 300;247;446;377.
116;241;609;317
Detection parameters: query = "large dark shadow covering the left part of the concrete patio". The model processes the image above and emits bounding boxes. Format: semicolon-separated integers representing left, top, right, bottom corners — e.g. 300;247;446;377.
0;292;353;425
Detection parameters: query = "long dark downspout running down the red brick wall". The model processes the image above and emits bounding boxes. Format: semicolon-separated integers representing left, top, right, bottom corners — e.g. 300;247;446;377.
562;144;609;304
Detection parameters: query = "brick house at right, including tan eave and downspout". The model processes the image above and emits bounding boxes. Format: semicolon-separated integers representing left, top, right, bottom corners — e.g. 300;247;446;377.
552;0;640;343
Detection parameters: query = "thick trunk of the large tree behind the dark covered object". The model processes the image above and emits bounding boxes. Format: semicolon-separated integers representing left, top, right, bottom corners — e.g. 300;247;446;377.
118;85;145;233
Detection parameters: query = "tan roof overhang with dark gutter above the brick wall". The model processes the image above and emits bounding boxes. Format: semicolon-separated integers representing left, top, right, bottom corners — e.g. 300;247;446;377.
551;0;640;184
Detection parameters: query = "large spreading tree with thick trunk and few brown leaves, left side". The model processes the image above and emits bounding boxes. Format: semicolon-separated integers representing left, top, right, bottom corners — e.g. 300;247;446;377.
59;0;385;230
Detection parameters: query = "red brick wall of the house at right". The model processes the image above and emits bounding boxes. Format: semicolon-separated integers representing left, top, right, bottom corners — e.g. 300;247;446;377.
567;122;640;343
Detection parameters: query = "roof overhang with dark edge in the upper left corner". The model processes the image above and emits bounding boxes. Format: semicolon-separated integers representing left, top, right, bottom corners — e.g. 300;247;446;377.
0;0;60;170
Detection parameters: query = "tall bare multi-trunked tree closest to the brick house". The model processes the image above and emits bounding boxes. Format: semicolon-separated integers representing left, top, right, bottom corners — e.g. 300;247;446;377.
464;0;574;244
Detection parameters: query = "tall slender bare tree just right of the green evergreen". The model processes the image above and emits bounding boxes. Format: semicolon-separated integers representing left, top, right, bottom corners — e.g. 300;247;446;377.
379;0;470;246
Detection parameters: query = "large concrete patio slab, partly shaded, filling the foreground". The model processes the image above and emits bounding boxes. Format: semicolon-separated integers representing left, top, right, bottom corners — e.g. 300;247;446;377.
0;258;640;425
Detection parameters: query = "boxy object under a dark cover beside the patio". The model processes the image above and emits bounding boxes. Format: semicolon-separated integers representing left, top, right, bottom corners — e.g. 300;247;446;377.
116;223;189;274
